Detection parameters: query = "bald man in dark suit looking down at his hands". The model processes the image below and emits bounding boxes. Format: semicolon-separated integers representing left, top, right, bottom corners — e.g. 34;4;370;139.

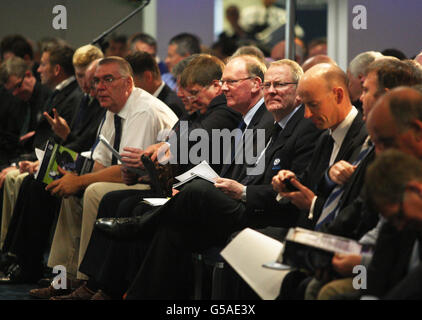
273;63;367;229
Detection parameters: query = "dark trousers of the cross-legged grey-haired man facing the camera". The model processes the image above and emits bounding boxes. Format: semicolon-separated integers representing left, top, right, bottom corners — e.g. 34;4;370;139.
127;179;245;299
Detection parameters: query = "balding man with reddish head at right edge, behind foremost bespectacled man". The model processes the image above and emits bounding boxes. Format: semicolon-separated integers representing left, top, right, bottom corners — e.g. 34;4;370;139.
319;87;422;299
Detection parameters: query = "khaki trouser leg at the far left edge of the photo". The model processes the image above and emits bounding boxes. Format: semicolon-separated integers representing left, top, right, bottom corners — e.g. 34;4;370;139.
0;169;28;249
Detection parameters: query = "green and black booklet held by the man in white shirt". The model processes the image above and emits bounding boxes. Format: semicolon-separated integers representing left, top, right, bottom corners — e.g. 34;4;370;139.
34;141;94;184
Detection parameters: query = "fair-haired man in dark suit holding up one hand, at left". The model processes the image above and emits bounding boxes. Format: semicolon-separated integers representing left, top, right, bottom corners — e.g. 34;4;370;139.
2;45;105;282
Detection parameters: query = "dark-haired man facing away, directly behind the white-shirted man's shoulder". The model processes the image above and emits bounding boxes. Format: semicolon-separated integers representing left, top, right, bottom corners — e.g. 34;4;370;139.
126;51;185;118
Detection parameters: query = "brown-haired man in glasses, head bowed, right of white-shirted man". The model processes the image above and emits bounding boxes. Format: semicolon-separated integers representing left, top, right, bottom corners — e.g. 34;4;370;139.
41;54;240;299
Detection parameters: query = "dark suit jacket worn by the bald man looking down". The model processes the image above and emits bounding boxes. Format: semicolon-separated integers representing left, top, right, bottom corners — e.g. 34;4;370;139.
298;113;368;229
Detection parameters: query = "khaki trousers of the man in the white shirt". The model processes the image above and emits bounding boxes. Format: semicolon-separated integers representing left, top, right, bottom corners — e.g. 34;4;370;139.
48;182;150;280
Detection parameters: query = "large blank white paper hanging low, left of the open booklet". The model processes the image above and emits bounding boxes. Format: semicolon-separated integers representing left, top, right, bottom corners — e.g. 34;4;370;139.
220;228;290;300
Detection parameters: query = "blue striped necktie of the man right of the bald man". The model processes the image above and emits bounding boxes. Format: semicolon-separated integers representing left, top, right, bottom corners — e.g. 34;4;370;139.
315;142;373;231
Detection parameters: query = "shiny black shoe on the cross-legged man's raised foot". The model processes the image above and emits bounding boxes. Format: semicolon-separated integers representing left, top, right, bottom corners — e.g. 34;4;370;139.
94;217;141;240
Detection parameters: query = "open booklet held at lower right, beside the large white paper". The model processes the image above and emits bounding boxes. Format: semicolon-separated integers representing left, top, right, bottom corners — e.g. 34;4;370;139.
264;228;368;272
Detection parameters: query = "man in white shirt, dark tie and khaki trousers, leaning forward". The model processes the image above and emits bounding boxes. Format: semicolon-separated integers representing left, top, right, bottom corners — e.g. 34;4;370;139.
30;57;178;298
